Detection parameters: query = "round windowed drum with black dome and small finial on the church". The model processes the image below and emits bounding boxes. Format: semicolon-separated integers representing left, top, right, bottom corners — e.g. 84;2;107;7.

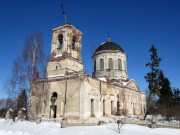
92;36;128;81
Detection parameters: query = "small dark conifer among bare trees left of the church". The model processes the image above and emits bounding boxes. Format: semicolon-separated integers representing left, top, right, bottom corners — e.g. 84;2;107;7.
17;90;27;110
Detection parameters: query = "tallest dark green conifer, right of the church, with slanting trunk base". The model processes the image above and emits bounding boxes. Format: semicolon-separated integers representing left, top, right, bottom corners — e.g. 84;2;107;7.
144;45;161;119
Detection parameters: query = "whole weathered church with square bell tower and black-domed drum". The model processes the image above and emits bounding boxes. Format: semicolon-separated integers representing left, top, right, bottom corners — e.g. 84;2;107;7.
30;23;146;120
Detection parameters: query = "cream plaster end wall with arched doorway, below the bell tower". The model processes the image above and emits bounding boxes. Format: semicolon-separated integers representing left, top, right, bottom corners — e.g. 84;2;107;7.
31;79;81;118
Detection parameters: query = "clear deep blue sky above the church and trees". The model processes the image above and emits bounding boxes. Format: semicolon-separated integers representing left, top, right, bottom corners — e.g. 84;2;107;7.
0;0;180;98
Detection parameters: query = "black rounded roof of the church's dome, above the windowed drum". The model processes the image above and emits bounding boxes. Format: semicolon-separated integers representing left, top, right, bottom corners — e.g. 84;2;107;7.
95;42;124;53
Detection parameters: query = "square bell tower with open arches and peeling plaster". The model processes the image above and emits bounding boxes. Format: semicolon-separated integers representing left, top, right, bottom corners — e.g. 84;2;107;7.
47;23;83;77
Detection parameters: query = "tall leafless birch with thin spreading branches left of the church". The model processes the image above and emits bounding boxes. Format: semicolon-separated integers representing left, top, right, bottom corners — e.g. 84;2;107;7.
4;33;46;118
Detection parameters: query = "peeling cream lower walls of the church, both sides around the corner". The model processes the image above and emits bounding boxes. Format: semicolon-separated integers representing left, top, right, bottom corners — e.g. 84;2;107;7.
31;75;146;119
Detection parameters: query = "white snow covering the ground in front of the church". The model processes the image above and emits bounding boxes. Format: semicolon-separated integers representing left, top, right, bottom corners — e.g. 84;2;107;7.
0;119;180;135
